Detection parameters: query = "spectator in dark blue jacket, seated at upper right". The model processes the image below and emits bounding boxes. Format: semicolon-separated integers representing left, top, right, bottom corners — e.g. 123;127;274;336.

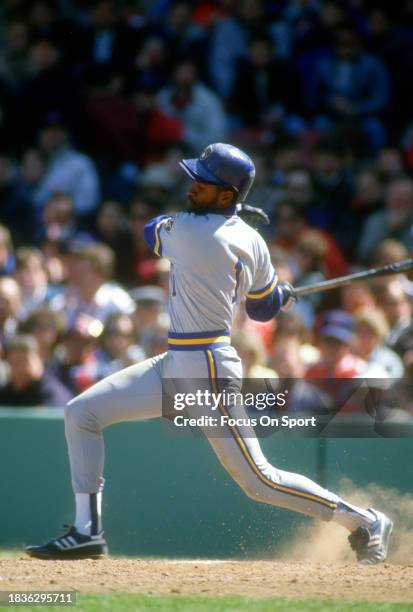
306;23;390;151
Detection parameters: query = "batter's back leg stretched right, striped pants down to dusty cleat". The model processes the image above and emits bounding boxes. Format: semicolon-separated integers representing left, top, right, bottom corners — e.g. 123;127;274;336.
206;351;392;562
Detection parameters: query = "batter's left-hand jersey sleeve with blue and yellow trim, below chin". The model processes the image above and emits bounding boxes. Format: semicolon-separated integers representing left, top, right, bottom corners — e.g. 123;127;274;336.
143;215;179;260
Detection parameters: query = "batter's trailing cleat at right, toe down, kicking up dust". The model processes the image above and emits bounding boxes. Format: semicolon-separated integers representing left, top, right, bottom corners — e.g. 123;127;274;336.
348;508;393;565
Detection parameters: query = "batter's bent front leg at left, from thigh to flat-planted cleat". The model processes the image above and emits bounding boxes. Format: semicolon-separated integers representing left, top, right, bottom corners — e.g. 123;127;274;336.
27;354;167;558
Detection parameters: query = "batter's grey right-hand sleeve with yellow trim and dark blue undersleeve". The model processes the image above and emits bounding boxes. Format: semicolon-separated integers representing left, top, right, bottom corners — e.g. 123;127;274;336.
246;235;283;321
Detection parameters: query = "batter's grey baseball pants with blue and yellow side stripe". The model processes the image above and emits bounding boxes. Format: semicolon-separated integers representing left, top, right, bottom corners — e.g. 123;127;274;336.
65;346;339;521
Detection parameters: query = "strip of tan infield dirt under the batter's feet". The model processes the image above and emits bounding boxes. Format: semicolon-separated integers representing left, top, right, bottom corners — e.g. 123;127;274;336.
0;558;413;602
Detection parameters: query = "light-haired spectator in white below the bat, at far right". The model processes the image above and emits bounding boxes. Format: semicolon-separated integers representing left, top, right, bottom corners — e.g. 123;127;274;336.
354;309;404;378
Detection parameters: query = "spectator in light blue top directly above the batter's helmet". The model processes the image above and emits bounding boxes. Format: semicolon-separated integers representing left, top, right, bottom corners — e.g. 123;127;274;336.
158;61;227;152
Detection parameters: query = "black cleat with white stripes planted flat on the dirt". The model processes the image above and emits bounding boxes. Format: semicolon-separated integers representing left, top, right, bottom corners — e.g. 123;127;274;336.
26;527;108;559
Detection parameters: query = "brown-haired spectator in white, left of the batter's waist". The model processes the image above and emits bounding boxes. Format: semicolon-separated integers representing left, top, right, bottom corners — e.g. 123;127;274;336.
50;241;135;327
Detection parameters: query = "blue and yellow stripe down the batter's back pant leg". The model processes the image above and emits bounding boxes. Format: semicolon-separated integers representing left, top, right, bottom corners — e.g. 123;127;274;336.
205;349;337;510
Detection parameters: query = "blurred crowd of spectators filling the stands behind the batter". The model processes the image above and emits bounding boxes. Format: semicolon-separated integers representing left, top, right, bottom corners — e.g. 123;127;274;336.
0;0;413;412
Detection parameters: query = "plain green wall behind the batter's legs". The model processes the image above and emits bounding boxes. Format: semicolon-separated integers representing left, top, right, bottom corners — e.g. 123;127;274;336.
0;409;413;558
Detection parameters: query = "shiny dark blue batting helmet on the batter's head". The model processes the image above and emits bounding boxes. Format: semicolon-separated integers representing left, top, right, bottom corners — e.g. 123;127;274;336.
179;142;255;202
